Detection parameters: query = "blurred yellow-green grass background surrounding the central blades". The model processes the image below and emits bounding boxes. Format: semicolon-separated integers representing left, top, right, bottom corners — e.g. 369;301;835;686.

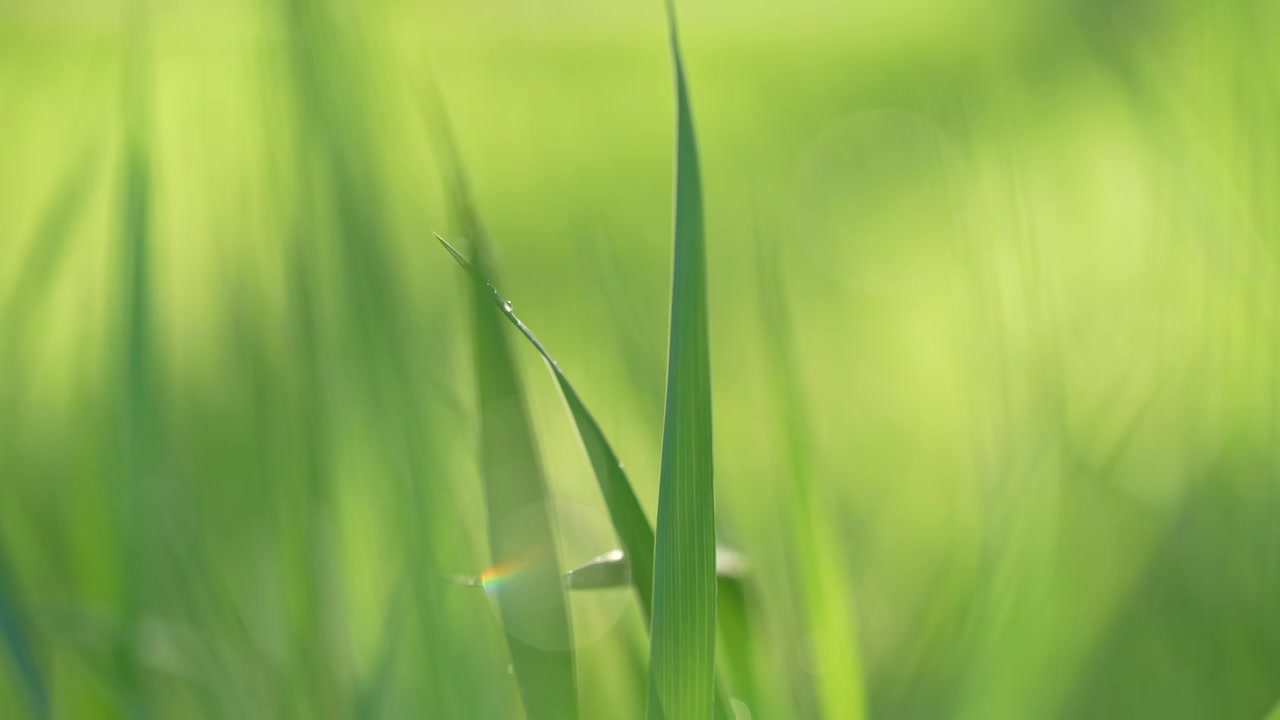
0;0;1280;719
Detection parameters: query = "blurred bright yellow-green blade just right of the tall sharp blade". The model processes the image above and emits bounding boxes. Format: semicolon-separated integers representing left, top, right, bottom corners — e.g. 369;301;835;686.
758;233;865;720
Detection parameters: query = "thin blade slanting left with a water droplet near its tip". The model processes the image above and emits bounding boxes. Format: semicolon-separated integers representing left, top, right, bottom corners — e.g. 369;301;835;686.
435;234;654;623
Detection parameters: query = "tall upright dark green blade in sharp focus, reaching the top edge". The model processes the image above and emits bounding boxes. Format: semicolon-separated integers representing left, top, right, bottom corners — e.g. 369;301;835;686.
648;1;716;720
